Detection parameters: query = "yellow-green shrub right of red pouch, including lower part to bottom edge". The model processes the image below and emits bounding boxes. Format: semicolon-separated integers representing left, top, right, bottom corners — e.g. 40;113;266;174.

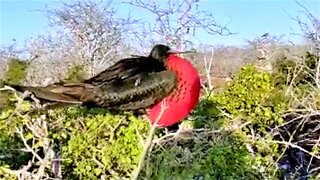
205;65;289;179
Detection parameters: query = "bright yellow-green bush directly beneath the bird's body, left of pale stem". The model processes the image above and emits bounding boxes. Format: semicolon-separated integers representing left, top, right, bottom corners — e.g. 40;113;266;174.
46;108;149;179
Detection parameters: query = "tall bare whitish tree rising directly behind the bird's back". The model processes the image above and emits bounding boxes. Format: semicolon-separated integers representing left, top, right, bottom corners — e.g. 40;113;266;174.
49;1;123;76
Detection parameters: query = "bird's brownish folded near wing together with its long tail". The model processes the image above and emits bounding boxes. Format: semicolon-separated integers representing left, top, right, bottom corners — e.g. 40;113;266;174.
8;71;177;110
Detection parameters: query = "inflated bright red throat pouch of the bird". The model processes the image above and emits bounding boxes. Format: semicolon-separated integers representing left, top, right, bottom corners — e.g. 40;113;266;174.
148;54;201;127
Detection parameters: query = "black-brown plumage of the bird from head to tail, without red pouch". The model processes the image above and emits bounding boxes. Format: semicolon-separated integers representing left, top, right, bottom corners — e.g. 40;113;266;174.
8;45;177;110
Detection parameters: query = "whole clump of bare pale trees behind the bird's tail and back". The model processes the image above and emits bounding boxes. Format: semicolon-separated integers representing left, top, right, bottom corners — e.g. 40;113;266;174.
23;0;134;84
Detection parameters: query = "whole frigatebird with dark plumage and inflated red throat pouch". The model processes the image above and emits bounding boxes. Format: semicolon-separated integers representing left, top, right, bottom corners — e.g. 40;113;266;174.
10;44;201;127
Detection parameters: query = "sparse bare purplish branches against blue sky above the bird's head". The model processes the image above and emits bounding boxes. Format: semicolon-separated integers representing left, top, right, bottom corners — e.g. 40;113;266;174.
126;0;232;49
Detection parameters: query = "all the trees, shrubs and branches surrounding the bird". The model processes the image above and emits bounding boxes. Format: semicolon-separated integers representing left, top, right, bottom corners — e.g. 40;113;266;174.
0;0;320;180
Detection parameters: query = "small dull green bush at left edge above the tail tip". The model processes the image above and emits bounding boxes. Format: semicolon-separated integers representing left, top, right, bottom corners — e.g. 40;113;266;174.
4;59;29;84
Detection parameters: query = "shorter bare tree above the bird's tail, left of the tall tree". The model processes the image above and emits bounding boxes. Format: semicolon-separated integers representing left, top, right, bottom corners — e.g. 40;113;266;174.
24;30;75;85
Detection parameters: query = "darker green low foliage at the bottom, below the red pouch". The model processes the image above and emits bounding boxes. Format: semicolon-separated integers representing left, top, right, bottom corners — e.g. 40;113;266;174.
143;135;260;180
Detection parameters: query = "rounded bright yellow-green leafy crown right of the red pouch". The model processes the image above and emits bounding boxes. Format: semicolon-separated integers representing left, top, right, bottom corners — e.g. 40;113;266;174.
212;66;287;134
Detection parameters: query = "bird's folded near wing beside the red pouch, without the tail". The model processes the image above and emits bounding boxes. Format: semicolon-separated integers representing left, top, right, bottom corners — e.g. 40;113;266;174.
88;71;177;110
